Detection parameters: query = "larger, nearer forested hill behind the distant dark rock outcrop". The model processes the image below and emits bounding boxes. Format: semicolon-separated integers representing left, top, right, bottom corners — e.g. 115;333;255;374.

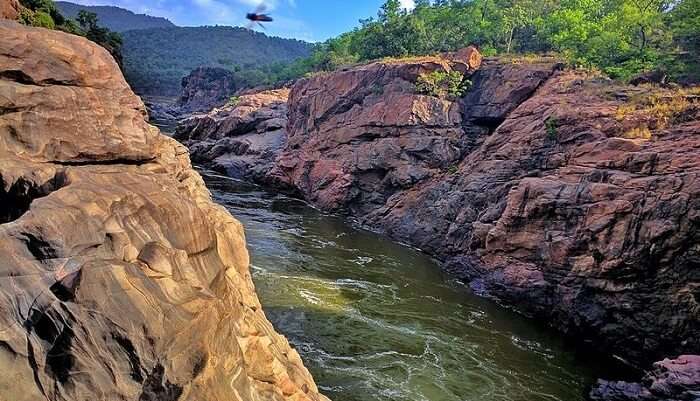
123;26;312;95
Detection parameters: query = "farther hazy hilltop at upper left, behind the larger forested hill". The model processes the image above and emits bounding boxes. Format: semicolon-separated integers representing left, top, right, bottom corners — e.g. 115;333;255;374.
56;1;175;32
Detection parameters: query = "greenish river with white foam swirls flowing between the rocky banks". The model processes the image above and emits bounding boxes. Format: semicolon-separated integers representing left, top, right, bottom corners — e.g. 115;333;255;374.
204;172;601;401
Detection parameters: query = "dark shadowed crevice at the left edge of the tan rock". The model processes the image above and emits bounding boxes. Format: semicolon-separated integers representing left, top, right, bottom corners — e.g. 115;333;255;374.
0;171;68;224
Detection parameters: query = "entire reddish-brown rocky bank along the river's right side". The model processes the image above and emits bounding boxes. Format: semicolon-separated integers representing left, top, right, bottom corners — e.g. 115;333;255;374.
175;49;700;400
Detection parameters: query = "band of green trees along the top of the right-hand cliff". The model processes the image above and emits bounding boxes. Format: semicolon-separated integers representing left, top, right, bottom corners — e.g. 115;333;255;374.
290;0;700;82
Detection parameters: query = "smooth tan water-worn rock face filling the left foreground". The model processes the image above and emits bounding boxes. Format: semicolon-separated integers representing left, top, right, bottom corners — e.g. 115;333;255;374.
0;21;326;401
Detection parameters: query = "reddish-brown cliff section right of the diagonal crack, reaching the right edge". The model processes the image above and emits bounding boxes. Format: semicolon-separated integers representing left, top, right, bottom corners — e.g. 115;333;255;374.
362;66;700;362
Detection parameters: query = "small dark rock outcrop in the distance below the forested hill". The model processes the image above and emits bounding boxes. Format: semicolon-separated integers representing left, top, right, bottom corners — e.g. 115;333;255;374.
178;67;236;113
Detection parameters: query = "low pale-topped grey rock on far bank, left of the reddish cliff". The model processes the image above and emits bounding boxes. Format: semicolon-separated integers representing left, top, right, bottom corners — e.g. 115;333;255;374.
174;89;289;181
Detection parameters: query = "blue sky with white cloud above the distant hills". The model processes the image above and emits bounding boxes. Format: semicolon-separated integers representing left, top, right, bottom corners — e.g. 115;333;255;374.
67;0;413;41
